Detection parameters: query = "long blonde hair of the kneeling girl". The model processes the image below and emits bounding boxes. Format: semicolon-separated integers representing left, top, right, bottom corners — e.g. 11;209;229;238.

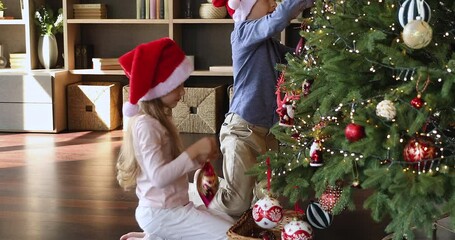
117;98;183;190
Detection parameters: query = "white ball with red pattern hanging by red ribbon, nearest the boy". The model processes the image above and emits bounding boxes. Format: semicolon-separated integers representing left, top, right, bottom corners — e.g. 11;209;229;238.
252;196;283;229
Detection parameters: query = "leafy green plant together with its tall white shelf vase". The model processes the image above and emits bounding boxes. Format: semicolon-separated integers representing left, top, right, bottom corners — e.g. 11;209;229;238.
35;6;63;69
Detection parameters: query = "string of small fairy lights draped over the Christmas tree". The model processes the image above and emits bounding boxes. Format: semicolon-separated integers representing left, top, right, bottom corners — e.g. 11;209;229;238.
266;0;455;180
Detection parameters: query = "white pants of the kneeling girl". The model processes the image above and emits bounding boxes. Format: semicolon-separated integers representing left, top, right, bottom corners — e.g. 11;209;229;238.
136;202;234;240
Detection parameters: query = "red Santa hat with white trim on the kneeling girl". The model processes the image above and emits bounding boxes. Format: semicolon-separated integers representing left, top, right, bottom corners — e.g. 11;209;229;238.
119;38;194;117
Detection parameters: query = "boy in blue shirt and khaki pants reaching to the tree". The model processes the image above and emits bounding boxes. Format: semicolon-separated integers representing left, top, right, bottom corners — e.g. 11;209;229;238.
209;0;314;216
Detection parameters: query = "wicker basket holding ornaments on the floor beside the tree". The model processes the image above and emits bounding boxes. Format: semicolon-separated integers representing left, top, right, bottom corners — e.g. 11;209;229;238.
227;209;299;240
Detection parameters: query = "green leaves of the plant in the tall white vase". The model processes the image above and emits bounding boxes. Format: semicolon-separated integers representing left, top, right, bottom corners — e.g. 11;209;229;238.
35;6;63;36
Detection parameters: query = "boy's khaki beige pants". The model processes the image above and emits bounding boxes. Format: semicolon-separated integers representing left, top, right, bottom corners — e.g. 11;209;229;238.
209;113;278;217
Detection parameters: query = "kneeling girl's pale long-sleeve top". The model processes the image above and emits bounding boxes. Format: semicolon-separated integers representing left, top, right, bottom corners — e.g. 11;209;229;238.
132;115;201;208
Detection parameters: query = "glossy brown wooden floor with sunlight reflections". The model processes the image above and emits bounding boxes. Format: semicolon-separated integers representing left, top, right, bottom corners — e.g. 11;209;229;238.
0;130;454;240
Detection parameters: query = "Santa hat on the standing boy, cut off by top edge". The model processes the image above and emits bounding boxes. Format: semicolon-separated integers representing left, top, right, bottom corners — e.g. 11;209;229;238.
212;0;257;22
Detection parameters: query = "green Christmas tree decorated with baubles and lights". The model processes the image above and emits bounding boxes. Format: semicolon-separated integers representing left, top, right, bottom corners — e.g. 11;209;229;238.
250;0;455;239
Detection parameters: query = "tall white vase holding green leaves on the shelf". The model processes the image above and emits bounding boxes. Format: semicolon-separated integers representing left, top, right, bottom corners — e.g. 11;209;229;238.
38;34;58;69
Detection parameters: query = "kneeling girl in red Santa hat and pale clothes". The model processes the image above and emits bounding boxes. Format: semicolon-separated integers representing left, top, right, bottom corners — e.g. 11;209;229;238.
117;38;233;240
